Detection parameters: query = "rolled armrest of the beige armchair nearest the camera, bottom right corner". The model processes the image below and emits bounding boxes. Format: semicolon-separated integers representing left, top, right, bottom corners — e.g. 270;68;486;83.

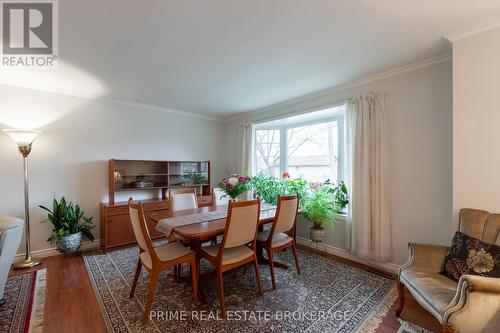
443;275;500;333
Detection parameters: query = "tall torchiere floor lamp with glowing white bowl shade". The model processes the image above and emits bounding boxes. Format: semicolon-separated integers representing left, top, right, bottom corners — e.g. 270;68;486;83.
3;129;41;269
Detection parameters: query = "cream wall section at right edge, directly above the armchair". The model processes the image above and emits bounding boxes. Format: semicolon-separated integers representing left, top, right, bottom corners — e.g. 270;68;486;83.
453;29;500;226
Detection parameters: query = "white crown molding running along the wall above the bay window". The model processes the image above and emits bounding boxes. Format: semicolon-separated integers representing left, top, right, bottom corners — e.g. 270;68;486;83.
223;54;452;121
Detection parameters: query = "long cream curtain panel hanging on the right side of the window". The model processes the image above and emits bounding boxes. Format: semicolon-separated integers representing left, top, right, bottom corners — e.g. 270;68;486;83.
346;91;392;261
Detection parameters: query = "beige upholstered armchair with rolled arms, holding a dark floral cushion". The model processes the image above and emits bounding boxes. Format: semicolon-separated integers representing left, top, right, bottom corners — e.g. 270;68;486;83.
396;209;500;333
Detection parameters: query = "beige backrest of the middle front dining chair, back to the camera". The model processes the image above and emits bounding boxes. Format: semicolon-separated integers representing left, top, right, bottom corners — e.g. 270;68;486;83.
222;199;260;248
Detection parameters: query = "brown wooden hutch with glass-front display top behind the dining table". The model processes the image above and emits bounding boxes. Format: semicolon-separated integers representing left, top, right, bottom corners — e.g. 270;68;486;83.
100;159;212;251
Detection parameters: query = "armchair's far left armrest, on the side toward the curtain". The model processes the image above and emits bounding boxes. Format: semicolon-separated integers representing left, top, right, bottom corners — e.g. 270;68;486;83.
399;242;449;274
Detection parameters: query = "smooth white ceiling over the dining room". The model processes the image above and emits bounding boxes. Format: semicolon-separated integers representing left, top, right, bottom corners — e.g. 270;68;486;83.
7;0;500;118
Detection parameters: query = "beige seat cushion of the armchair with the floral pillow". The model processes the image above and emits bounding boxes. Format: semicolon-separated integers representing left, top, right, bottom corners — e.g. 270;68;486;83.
400;268;457;319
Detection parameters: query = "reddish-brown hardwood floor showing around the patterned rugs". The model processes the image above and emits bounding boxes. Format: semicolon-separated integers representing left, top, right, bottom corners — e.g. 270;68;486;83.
10;250;441;333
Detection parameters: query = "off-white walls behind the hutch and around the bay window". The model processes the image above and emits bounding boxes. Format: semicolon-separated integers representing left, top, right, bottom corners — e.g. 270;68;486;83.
0;61;453;263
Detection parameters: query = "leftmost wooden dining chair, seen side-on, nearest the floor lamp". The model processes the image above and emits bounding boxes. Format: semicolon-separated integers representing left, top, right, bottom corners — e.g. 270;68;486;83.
128;198;198;323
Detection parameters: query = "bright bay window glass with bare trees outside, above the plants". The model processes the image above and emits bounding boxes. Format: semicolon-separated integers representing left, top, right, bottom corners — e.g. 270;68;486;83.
254;105;345;183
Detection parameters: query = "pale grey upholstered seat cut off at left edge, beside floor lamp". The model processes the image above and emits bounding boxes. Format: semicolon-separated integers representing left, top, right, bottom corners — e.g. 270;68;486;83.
0;216;24;305
